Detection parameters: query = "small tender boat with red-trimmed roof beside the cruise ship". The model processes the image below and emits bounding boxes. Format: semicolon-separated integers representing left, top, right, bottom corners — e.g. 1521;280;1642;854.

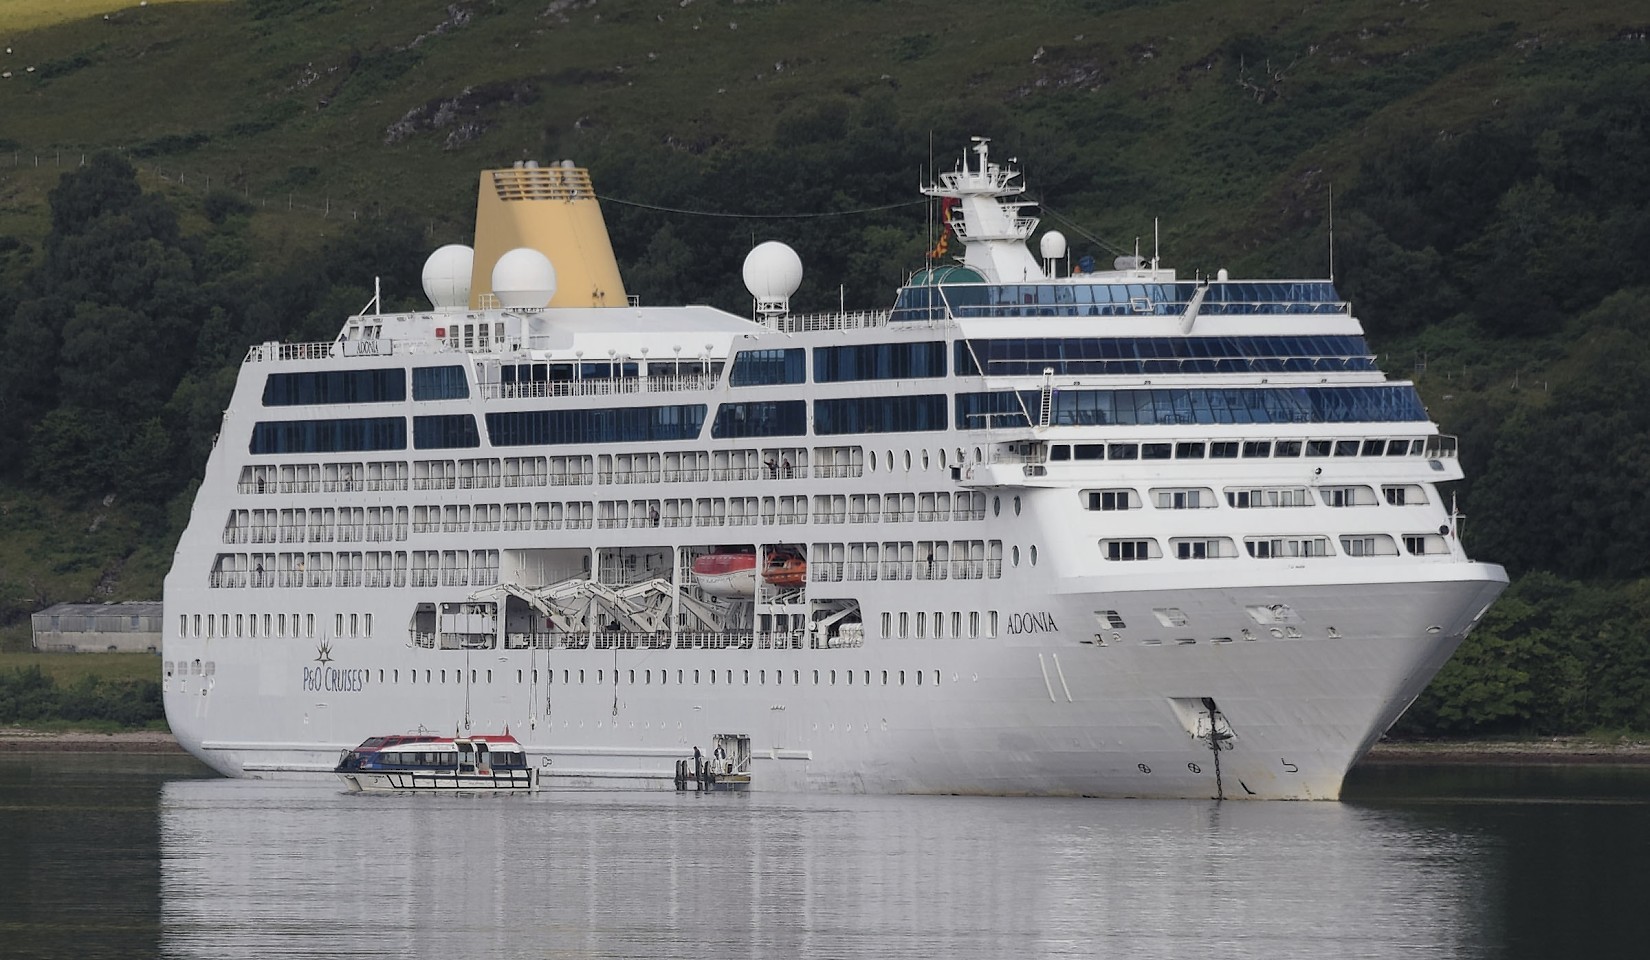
333;734;538;793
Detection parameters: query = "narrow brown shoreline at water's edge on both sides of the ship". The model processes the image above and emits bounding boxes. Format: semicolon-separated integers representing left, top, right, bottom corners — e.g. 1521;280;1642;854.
0;727;1650;765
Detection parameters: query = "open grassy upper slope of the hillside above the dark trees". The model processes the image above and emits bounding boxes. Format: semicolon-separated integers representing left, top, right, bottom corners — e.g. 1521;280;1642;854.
0;0;1643;282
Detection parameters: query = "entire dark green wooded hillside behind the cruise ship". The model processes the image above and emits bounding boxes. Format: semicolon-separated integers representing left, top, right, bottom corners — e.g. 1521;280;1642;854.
0;0;1650;734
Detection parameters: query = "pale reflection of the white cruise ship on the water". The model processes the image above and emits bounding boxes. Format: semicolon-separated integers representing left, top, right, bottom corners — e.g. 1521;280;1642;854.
160;780;1505;958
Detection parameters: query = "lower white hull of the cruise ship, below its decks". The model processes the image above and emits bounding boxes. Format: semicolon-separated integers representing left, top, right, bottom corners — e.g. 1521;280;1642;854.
167;567;1502;800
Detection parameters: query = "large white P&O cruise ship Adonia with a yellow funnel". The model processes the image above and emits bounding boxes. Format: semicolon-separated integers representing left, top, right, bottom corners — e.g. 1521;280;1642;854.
163;139;1506;800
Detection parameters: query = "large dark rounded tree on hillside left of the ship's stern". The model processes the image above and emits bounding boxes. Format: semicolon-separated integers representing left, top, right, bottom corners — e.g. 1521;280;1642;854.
0;153;203;495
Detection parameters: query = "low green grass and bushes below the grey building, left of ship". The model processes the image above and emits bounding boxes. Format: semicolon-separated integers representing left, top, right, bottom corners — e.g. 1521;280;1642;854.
0;653;167;729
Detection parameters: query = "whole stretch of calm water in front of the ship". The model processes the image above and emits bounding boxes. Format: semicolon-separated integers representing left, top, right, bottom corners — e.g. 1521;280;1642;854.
0;755;1650;960
